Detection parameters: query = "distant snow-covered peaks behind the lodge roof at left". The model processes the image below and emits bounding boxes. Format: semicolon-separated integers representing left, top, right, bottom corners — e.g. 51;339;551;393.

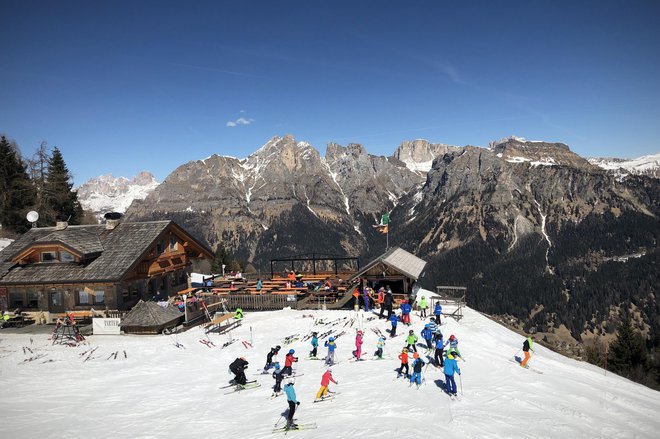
77;171;159;216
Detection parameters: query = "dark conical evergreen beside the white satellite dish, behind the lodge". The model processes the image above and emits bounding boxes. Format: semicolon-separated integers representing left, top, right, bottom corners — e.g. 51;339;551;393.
44;147;84;226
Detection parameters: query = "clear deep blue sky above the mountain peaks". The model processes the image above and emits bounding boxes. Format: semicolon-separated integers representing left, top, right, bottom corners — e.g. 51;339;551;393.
0;0;660;184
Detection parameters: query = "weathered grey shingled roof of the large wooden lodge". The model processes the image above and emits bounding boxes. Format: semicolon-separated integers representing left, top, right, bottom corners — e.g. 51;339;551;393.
0;221;213;285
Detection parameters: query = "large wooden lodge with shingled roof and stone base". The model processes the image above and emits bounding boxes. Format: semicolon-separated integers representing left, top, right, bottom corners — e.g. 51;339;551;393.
0;220;213;321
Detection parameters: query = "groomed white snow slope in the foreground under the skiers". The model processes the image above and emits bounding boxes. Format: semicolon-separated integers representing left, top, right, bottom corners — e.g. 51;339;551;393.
0;309;660;439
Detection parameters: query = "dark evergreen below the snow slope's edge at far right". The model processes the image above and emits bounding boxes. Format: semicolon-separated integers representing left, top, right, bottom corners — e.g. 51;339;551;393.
608;319;647;377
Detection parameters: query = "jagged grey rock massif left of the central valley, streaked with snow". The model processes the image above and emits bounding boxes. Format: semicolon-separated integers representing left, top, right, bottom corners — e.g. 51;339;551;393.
128;136;423;262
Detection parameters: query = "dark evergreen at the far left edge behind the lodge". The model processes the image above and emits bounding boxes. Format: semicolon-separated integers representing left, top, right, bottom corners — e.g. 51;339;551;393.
0;136;35;233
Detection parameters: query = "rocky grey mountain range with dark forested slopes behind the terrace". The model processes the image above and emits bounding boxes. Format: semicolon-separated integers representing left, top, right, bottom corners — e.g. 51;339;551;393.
73;135;660;368
